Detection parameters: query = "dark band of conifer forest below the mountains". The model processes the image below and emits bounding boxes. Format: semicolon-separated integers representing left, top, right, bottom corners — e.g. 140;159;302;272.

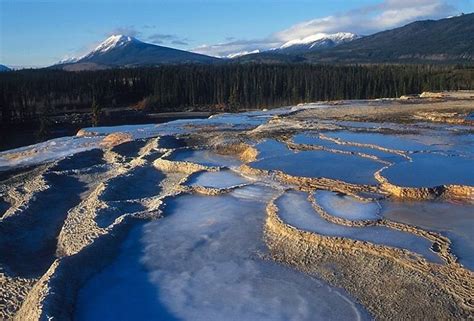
0;64;474;123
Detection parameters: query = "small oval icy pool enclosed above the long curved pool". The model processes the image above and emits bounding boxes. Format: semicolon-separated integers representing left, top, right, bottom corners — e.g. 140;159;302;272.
314;191;380;221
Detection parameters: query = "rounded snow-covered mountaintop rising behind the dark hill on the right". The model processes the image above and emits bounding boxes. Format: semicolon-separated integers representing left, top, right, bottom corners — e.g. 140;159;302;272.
275;32;361;53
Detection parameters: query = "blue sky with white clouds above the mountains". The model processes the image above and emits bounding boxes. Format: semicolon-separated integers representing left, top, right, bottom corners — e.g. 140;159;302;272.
0;0;474;68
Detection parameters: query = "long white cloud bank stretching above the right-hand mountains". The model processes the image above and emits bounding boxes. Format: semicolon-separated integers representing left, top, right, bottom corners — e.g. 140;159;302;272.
193;0;462;57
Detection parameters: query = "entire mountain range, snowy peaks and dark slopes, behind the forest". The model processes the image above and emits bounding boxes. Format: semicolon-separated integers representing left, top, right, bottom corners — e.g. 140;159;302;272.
51;13;474;71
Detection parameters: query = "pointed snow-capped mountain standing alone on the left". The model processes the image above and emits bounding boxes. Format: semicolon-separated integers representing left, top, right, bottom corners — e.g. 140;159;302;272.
58;35;217;70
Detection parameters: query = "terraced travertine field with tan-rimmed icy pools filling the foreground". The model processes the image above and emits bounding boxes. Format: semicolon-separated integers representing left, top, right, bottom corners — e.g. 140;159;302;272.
0;92;474;320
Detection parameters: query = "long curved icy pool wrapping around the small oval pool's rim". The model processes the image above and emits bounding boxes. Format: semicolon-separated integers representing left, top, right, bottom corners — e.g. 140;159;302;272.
276;191;442;263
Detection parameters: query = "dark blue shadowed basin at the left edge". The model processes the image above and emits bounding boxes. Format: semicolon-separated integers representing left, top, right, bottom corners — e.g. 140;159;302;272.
0;173;86;277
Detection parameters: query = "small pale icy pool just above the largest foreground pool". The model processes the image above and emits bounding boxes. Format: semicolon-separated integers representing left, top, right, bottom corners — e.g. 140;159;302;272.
187;170;249;188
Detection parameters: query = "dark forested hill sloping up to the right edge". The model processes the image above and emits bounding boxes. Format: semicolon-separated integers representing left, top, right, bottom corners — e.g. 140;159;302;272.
239;13;474;63
